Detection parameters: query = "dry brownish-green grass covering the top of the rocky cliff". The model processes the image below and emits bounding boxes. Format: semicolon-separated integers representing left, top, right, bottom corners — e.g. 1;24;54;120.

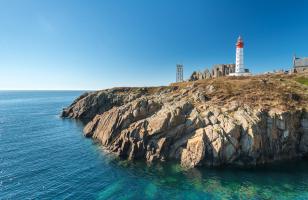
108;72;308;110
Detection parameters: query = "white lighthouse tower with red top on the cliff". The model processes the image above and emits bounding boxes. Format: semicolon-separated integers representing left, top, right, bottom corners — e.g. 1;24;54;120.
229;36;251;76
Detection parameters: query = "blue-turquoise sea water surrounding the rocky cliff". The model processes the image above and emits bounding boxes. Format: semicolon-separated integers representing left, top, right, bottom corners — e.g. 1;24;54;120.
0;92;308;200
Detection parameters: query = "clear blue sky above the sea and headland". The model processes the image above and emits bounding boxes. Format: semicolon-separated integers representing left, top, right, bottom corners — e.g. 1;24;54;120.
0;0;308;89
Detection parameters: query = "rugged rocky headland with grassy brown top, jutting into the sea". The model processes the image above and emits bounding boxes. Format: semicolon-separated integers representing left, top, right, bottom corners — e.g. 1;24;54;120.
62;72;308;168
